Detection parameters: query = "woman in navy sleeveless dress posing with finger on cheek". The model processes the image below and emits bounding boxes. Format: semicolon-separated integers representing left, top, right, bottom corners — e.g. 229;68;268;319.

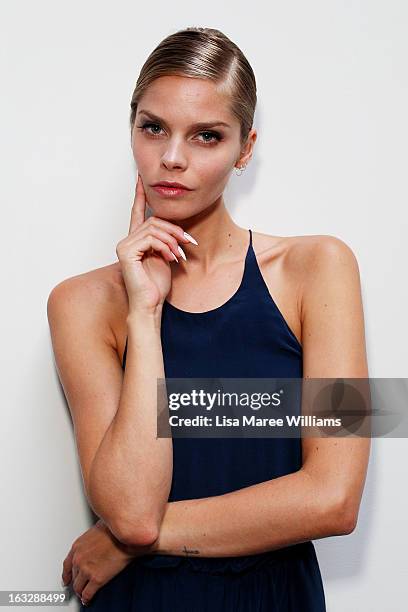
48;28;369;612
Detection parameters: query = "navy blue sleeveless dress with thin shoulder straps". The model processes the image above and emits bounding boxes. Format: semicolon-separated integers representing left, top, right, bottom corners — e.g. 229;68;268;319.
81;230;326;612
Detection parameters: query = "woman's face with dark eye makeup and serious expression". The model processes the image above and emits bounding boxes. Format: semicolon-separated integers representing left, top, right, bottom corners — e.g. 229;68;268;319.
132;76;252;221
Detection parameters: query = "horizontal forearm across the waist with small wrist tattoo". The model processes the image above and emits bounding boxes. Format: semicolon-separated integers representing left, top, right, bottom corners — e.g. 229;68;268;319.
147;470;342;557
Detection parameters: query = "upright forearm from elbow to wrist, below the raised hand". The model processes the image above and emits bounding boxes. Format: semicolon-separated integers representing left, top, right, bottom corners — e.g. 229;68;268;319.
89;315;173;540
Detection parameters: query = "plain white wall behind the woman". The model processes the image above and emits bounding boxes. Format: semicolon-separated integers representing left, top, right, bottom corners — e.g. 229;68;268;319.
0;0;408;612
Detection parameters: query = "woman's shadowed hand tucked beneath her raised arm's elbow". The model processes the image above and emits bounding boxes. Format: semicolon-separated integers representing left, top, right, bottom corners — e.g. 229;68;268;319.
62;520;151;604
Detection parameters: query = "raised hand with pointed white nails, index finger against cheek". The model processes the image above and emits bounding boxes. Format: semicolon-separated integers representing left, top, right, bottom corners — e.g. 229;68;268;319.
116;175;199;313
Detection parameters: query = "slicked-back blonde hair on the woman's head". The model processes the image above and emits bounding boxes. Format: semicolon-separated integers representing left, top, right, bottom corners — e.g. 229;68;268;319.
130;27;257;145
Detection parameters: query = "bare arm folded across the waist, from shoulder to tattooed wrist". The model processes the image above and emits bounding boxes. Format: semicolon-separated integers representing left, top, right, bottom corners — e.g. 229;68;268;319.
135;237;370;557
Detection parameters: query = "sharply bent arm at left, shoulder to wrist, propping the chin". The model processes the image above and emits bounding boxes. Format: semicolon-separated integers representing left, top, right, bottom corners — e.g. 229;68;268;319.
47;272;172;545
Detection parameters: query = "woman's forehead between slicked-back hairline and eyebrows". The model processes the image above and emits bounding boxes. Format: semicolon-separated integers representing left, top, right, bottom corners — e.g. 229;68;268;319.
138;75;236;124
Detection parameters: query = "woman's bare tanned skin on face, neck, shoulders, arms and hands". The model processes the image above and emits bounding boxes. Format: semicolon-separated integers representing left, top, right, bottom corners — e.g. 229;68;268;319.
48;76;370;601
